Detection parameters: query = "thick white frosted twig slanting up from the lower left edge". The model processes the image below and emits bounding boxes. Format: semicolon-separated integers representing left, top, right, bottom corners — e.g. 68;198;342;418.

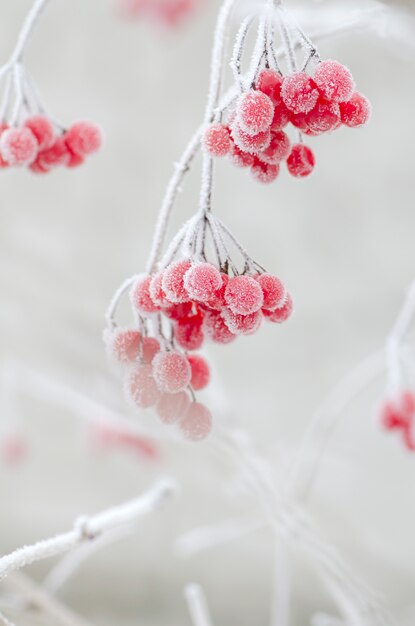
0;479;177;580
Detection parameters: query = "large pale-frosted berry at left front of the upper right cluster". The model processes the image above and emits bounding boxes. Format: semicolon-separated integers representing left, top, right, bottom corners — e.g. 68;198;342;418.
236;90;274;135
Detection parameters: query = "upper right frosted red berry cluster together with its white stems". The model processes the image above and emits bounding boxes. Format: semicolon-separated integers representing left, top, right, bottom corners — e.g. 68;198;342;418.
203;6;370;183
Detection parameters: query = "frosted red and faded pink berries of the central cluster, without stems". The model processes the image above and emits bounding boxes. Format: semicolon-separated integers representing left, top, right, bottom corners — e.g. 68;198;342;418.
107;259;292;441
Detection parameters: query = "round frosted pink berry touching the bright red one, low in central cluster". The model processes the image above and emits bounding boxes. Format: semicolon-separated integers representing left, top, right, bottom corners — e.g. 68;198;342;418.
153;351;192;393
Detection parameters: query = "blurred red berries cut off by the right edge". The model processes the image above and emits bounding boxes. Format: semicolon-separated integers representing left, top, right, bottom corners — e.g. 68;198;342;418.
380;390;415;451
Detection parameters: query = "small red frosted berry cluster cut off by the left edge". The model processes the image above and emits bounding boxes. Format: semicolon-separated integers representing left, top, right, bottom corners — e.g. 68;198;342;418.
0;115;102;174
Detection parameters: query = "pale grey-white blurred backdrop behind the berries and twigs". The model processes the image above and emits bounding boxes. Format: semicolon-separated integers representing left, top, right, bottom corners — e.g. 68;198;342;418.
0;0;415;626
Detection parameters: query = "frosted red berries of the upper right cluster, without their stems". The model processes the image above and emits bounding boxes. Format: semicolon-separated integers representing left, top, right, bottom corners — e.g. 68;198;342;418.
203;61;370;183
